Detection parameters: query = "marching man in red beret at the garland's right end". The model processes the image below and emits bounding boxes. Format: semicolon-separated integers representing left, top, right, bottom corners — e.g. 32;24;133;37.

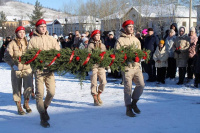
115;20;145;117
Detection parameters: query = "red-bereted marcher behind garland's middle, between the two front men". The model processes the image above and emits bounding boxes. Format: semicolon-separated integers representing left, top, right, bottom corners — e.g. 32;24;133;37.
88;30;107;106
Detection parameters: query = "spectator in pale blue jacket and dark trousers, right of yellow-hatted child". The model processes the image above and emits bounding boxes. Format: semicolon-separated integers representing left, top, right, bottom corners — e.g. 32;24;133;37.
165;29;176;79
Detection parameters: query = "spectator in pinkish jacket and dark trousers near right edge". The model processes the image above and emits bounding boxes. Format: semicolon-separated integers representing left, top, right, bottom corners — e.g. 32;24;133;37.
187;27;198;80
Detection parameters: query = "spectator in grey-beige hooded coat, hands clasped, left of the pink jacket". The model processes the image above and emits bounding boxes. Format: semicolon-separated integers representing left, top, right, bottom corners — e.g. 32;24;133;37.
173;27;190;85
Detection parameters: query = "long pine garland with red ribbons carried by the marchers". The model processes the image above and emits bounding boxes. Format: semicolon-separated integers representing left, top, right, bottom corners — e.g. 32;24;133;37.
18;47;150;80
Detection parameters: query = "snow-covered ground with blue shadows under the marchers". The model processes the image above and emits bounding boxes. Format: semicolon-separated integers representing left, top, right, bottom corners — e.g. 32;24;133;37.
0;63;200;133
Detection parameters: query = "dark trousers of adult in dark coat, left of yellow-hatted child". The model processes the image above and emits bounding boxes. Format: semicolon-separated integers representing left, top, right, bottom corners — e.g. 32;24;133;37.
146;60;156;81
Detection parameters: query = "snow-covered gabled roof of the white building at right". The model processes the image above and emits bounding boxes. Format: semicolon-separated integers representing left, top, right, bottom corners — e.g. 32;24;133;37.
102;4;197;20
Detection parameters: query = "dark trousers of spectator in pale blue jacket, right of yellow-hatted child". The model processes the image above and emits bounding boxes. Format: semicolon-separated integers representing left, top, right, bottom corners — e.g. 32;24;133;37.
167;57;176;79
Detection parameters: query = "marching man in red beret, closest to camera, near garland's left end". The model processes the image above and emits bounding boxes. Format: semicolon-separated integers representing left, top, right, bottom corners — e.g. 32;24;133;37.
28;19;60;127
